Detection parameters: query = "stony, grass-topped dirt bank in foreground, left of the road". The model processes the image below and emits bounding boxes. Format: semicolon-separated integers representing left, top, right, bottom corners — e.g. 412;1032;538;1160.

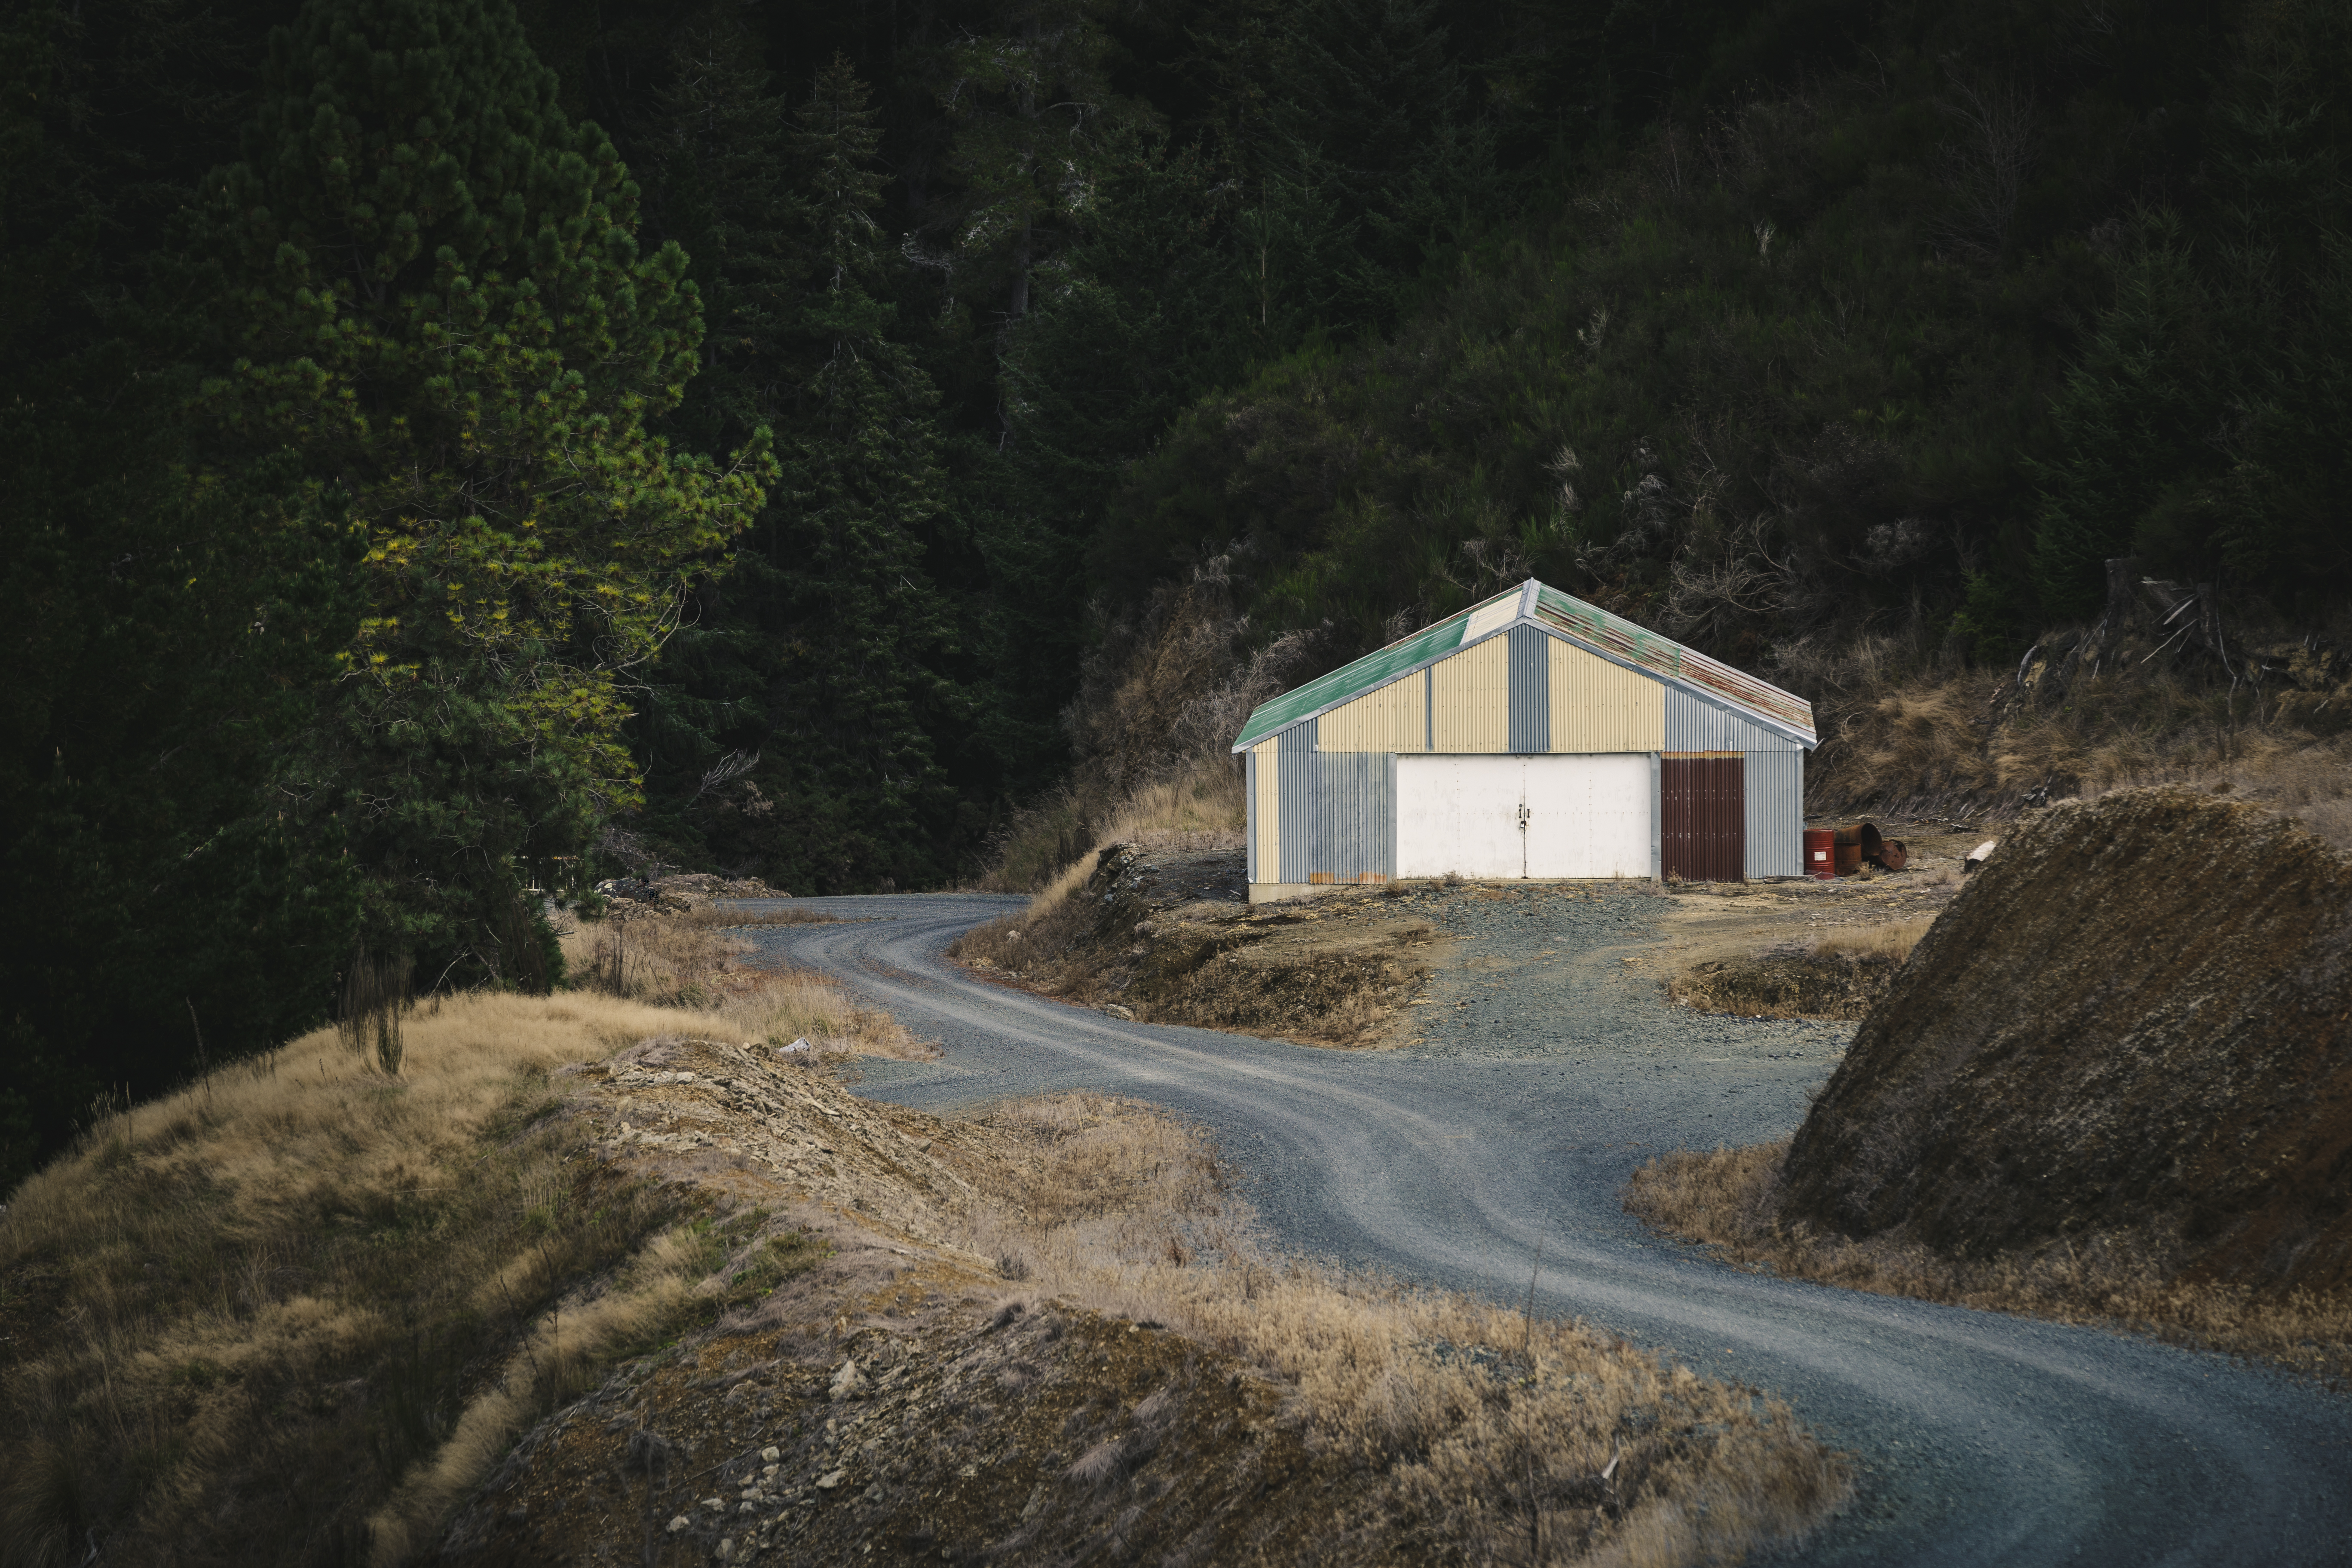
438;1039;1847;1566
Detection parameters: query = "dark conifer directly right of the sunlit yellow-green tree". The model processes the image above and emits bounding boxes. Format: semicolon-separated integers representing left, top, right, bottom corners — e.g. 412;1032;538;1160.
637;55;965;891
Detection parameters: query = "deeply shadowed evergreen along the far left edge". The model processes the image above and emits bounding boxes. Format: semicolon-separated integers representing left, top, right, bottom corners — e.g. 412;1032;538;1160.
0;5;358;1192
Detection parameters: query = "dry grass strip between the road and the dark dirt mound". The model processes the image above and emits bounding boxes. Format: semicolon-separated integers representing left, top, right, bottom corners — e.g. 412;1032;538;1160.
1625;1142;2352;1387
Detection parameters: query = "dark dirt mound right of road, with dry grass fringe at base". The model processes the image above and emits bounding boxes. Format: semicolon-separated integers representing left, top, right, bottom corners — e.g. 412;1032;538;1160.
1625;790;2352;1384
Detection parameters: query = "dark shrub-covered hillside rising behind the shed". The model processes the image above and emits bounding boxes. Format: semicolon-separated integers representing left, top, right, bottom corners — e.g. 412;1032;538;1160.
1093;5;2352;665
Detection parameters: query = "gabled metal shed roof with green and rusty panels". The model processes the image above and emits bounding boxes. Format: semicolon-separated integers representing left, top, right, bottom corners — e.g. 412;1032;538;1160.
1232;578;1818;752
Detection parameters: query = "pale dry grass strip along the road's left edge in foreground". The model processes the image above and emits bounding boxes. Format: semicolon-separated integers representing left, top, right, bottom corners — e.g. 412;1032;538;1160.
940;1093;1849;1563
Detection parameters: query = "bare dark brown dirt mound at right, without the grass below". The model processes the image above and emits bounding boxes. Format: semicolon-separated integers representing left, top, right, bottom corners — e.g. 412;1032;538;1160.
1780;790;2352;1291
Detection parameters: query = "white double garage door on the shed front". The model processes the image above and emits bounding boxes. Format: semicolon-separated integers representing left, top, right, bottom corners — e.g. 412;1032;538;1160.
1397;752;1651;877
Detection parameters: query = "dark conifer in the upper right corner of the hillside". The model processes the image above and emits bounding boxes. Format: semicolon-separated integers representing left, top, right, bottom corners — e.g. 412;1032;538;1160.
2034;5;2352;616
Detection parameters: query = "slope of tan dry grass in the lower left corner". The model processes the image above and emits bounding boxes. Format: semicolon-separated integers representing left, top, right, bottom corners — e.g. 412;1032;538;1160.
0;994;729;1563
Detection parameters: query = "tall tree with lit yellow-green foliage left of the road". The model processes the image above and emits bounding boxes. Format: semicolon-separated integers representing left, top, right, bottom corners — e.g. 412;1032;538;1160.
205;0;764;985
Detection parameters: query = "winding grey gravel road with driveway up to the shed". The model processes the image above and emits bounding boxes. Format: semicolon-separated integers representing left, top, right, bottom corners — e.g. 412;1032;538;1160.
746;893;2352;1563
